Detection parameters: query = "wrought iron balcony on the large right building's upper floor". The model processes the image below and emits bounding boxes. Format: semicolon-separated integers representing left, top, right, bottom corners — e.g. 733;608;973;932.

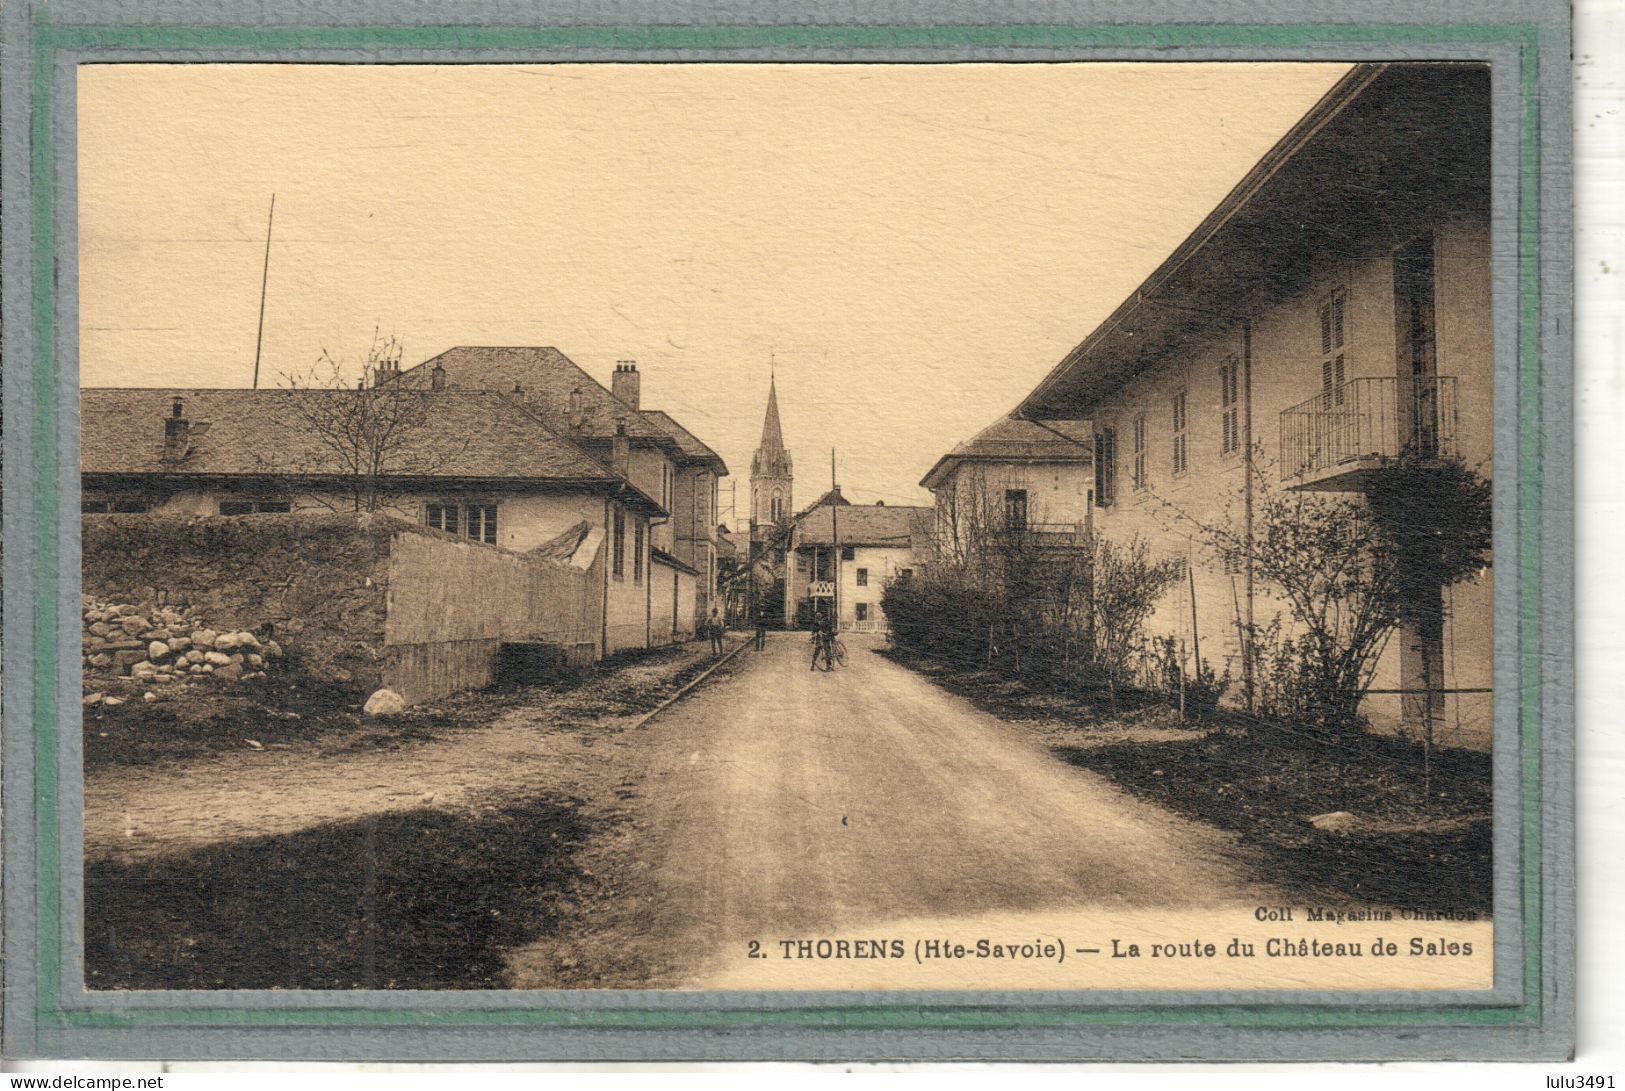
1281;377;1456;491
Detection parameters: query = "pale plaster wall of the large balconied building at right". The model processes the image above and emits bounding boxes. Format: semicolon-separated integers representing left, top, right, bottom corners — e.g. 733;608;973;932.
1094;209;1493;746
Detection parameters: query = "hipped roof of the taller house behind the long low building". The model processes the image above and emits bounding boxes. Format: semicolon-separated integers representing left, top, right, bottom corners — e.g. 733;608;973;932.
401;345;678;452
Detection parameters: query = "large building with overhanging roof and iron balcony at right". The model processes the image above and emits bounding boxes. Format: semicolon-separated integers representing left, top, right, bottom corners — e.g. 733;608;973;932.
1017;63;1492;746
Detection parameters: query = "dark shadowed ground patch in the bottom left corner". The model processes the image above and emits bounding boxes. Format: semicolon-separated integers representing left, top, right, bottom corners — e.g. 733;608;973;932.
85;802;587;989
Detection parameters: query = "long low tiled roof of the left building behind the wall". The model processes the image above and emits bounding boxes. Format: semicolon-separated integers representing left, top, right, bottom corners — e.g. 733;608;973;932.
80;387;637;486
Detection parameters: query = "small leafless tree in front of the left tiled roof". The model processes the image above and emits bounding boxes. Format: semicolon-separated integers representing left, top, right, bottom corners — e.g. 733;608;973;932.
271;332;471;512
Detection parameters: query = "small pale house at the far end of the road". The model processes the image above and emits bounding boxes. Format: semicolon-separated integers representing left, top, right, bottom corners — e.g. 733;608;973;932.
785;488;933;632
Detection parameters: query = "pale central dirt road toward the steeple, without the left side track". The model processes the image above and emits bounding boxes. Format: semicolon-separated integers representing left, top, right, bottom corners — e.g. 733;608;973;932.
510;634;1261;987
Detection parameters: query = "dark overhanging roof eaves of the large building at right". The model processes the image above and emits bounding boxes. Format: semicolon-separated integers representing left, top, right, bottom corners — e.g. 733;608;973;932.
1016;62;1492;421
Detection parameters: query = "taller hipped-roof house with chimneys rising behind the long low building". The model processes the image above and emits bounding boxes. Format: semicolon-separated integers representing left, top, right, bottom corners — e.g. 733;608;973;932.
401;345;728;631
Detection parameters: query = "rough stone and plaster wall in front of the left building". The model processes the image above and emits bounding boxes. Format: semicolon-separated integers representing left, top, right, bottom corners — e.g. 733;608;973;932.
81;512;603;702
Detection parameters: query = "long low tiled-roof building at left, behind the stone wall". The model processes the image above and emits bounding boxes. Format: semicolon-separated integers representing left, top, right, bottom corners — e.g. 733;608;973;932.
80;387;666;654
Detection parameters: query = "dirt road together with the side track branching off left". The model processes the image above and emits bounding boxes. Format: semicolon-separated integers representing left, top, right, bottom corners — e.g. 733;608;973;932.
85;632;1261;987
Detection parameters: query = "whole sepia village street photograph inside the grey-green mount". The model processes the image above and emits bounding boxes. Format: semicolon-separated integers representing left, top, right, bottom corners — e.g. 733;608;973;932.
72;60;1495;993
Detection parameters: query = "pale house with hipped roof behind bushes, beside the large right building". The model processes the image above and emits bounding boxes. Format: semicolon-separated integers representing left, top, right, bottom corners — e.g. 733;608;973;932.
920;418;1095;548
